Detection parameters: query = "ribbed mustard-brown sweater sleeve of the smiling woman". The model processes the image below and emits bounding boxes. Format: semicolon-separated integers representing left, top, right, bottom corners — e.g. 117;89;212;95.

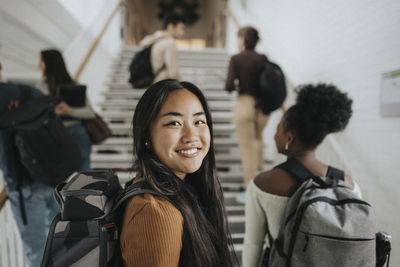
120;194;183;267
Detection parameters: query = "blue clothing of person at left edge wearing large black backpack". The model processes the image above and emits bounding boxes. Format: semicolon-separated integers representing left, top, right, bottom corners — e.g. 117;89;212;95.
0;83;59;267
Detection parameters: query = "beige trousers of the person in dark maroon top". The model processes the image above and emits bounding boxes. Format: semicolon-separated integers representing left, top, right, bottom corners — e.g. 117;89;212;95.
233;94;269;187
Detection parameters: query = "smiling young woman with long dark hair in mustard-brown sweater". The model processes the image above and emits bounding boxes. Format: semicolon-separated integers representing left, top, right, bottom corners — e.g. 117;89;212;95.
121;80;237;267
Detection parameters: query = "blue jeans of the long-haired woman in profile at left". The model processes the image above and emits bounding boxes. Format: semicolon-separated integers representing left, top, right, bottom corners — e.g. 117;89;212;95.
67;123;92;171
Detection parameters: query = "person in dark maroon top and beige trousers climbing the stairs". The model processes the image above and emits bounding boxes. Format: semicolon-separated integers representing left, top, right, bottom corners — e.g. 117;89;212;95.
225;26;269;203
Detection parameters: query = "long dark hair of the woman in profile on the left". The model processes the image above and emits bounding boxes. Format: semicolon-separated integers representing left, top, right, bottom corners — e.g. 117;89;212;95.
40;49;74;95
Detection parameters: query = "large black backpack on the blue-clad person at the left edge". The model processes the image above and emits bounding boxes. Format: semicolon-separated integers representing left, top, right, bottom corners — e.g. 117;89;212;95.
0;86;82;187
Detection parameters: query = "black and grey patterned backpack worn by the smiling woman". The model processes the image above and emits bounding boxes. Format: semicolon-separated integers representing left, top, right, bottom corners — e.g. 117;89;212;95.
41;170;173;267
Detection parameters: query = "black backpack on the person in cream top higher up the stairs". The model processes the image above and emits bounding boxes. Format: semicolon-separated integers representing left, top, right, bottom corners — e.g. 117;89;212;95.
129;42;165;88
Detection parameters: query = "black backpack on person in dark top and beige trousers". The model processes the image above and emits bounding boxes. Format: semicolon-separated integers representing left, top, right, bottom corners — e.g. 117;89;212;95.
255;55;286;115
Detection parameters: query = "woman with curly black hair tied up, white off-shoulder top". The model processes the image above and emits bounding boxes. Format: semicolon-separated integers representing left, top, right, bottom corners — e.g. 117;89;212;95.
243;84;361;267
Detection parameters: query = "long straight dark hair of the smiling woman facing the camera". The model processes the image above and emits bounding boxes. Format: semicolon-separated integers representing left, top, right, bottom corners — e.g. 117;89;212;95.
133;80;238;267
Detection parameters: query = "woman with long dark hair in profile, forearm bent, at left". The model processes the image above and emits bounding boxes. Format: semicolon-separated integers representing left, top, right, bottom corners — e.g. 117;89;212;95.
38;49;95;171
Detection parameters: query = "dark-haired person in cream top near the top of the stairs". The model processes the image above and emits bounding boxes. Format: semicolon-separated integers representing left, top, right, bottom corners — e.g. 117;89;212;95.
140;13;185;83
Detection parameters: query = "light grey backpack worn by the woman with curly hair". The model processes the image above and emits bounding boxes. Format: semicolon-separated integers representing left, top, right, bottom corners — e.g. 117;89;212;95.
265;158;376;267
